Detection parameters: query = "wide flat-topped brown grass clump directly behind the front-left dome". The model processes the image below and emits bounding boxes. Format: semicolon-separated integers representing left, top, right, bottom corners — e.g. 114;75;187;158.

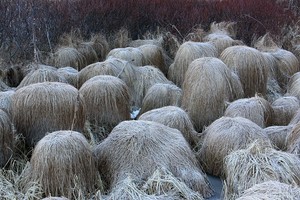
12;82;86;146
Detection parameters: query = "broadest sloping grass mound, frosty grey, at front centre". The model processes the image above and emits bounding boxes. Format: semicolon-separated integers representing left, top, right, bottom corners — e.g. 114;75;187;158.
94;120;212;197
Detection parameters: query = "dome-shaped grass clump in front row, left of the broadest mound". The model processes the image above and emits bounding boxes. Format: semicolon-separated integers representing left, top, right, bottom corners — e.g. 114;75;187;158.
23;130;98;198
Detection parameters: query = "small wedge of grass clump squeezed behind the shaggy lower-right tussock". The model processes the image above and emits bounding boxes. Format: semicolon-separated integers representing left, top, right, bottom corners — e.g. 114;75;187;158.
264;125;293;151
